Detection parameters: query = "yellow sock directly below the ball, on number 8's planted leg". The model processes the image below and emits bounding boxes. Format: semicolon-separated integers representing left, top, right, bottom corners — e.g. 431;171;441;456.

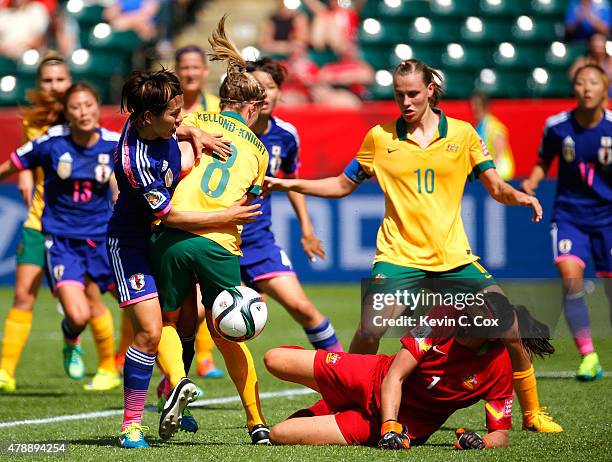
213;335;266;430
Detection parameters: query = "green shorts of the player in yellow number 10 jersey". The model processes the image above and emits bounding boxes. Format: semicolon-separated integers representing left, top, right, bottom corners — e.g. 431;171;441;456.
370;261;497;291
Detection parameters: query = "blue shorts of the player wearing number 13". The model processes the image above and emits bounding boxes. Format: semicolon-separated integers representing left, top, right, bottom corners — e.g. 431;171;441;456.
45;236;115;293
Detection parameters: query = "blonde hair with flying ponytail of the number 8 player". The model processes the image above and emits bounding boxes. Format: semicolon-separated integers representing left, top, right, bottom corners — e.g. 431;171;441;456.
208;15;266;108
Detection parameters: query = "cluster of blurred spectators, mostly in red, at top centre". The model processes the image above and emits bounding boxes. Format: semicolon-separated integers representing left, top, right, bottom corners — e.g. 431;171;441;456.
258;0;374;108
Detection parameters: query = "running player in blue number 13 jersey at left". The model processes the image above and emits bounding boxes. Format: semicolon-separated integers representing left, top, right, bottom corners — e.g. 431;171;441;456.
0;84;120;389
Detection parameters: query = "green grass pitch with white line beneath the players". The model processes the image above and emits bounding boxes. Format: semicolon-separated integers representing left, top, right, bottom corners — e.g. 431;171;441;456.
0;283;612;462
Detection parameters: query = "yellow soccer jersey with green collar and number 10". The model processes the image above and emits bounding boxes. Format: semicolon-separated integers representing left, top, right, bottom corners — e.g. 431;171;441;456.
345;109;495;271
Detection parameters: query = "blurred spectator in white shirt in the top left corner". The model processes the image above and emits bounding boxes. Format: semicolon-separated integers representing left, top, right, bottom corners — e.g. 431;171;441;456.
0;0;51;59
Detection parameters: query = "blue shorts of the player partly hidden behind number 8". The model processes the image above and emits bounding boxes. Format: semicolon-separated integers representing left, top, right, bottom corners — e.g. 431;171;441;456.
240;243;295;289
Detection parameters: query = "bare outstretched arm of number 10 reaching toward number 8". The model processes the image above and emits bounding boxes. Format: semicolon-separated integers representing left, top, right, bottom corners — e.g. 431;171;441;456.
264;173;359;198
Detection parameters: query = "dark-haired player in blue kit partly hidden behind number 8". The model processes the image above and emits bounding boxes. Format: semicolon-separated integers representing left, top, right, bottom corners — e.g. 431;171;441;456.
240;58;342;351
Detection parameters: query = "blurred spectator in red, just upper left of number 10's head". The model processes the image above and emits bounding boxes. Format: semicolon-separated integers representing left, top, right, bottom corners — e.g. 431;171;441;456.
311;43;374;108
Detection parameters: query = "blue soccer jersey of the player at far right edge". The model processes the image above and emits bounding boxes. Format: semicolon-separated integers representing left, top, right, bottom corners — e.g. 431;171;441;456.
539;110;612;225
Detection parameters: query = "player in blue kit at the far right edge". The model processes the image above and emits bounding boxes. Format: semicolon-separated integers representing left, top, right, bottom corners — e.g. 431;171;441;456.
522;64;612;381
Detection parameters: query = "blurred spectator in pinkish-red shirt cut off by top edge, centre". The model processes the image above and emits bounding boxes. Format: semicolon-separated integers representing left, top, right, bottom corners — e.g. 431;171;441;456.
304;0;364;55
